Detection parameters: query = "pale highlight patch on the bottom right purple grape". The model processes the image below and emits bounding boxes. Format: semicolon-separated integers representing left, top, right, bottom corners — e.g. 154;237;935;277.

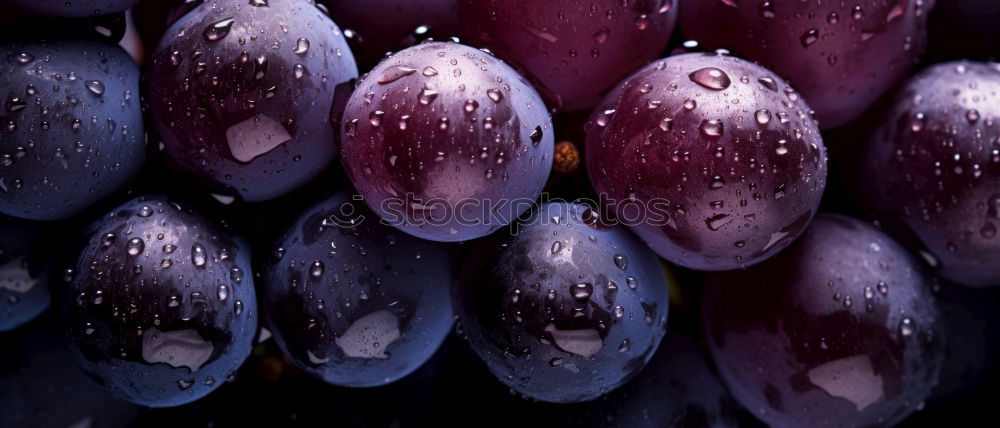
809;355;885;412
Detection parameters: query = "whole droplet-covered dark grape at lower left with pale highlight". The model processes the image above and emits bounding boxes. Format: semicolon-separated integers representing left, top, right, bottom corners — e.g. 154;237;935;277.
66;196;257;407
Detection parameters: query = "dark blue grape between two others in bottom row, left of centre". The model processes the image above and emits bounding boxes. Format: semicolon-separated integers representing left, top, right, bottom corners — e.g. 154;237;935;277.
264;191;452;387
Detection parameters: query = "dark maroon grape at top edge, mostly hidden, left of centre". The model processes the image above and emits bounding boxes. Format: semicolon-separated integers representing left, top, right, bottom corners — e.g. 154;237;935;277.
321;0;458;68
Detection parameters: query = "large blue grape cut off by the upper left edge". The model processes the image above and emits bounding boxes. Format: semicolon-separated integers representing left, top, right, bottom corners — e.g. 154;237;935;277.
0;40;146;220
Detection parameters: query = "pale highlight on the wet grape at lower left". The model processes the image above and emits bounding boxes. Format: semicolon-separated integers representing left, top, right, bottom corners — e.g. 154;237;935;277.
142;328;214;372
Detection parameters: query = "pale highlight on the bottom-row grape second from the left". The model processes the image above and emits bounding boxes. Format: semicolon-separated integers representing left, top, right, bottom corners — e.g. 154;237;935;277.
334;309;399;358
